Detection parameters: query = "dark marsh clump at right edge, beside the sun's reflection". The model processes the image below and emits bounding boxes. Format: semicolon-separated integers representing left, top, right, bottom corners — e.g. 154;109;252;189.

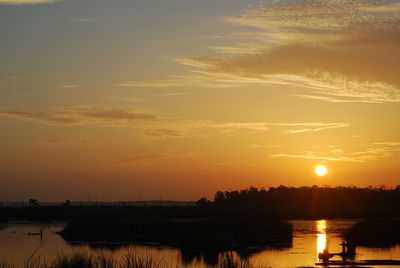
344;219;400;248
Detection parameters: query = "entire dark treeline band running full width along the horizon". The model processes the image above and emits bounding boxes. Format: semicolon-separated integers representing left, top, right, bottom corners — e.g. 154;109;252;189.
0;186;400;221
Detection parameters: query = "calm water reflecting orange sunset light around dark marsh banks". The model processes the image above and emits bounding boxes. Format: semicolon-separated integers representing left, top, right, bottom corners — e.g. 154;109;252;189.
0;220;400;268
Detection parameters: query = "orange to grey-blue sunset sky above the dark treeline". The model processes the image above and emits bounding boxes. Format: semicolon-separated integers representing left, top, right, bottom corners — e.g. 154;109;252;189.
0;0;400;201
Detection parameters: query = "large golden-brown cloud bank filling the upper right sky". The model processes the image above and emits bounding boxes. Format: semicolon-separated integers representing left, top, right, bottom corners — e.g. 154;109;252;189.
120;0;400;103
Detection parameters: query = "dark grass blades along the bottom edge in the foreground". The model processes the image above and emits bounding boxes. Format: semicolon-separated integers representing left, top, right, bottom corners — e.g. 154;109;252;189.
0;250;254;268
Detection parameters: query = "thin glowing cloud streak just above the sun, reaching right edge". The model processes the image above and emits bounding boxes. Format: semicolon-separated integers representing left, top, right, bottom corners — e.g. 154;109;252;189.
270;142;400;162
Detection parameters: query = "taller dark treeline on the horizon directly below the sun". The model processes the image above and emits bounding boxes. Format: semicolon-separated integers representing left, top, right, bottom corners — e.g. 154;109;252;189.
197;186;400;219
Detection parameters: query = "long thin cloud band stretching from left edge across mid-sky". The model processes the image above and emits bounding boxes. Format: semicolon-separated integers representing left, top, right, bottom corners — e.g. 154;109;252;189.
0;106;351;139
